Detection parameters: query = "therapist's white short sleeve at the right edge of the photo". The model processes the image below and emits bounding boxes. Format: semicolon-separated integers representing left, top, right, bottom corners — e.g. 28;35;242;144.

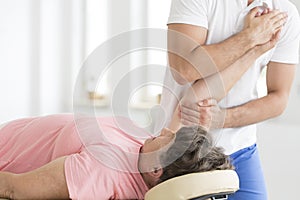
271;4;300;64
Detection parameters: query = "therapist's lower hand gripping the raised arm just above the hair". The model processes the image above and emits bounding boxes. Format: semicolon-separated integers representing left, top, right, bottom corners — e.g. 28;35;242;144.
179;98;226;130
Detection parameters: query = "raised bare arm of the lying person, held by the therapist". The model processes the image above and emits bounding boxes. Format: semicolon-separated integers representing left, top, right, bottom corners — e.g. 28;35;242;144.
169;47;268;131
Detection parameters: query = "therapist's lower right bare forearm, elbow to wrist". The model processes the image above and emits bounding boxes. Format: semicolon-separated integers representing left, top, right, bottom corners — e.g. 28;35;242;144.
224;93;288;128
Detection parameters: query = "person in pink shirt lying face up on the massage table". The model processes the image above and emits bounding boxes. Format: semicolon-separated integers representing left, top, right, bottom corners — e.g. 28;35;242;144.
0;111;232;199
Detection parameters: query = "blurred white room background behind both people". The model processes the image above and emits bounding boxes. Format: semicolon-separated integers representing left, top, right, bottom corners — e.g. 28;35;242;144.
0;0;300;200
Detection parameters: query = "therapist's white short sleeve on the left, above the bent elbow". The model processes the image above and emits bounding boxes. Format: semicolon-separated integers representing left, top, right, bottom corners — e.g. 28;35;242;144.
168;0;208;28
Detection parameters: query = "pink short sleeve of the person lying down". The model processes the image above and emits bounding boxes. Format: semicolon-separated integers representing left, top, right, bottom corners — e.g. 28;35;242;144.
65;151;118;199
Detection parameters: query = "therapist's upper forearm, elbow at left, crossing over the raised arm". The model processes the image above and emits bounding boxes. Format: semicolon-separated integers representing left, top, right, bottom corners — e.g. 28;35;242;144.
169;30;255;84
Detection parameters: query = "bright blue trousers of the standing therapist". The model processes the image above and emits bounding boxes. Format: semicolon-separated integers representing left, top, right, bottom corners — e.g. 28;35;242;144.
229;144;268;200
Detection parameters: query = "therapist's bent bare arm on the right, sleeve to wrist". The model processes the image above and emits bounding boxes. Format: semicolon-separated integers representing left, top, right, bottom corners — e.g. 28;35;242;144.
224;62;296;128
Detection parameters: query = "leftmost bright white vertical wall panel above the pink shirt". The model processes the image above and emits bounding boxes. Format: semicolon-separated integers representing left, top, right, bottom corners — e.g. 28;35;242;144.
0;0;31;122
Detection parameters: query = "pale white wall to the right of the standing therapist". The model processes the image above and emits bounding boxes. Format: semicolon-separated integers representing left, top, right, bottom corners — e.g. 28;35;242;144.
258;0;300;200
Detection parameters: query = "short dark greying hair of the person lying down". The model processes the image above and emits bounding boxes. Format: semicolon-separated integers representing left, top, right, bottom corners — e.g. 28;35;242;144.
159;126;234;183
